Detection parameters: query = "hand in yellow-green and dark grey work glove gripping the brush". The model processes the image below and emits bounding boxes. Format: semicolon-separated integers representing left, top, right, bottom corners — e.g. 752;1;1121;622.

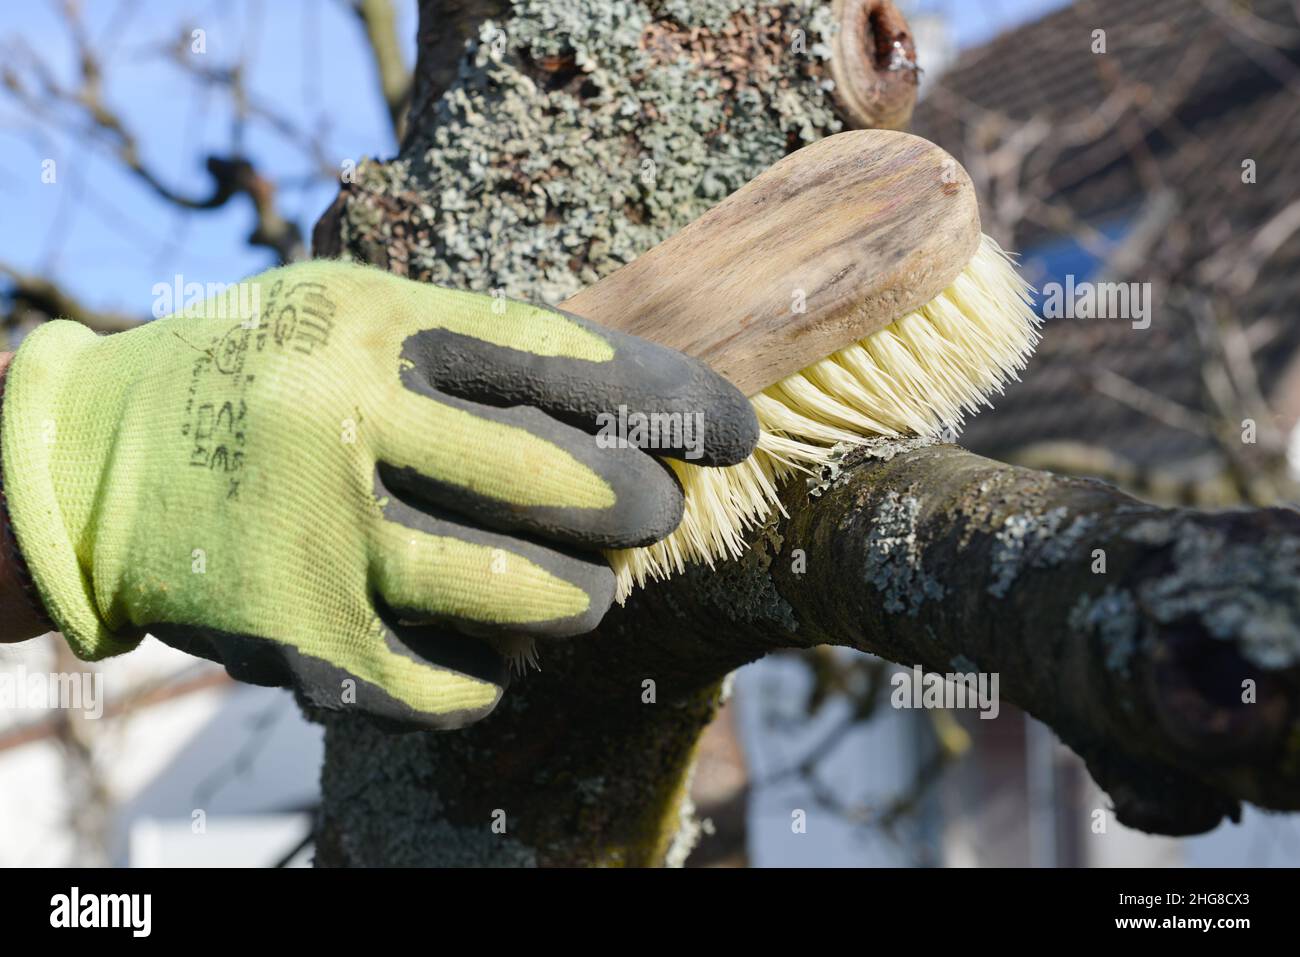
0;261;758;728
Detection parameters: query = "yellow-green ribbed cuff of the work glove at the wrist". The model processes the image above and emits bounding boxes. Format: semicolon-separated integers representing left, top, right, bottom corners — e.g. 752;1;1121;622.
0;320;143;661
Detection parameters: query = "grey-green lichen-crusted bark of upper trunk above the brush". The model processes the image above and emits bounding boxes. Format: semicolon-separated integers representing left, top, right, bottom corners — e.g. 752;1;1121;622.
317;0;840;303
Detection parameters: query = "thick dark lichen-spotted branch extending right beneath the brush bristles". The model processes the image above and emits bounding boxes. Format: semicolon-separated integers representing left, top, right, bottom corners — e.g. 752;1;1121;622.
602;443;1300;833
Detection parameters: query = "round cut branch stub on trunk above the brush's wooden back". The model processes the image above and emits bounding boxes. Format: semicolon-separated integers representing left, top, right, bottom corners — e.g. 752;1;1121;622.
831;0;920;130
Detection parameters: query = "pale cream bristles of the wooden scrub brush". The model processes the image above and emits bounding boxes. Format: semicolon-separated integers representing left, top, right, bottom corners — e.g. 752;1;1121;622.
607;235;1040;602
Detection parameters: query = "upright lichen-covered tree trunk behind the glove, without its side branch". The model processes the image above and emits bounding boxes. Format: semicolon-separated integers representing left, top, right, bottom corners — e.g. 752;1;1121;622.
315;0;840;865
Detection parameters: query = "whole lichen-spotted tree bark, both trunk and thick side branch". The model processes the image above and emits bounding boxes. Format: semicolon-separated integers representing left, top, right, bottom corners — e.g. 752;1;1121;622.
306;0;1300;865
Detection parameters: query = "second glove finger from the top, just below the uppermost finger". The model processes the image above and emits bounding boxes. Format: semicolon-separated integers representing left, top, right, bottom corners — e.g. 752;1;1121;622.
378;382;685;549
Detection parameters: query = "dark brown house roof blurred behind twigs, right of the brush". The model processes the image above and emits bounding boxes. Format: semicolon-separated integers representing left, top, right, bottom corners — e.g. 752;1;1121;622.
913;0;1300;471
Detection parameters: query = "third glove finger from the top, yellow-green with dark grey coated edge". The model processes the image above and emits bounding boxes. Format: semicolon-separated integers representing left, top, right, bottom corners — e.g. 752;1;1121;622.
371;475;615;637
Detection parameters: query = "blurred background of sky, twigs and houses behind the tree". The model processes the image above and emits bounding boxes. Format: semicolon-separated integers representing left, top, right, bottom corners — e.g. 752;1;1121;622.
0;0;1300;866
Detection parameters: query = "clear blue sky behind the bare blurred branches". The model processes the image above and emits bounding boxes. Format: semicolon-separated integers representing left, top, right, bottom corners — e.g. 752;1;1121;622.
0;0;1062;316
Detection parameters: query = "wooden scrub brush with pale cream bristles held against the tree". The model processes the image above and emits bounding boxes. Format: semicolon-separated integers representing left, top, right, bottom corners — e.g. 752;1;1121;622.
560;130;1039;602
